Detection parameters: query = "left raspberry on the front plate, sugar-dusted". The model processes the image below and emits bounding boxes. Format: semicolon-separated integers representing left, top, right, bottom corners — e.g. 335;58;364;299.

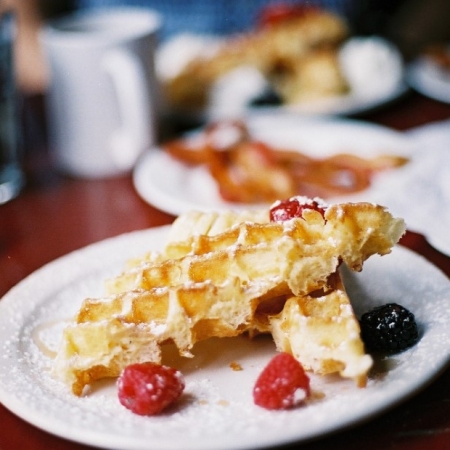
117;362;185;416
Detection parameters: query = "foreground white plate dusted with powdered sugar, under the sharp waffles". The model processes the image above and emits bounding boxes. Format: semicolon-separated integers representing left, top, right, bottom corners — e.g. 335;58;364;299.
0;227;450;450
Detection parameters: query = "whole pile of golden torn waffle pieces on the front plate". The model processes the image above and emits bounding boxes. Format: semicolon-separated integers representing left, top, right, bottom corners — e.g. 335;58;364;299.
53;203;404;395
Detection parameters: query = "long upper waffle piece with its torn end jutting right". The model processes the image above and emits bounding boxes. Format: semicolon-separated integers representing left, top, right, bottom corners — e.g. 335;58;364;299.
108;203;405;295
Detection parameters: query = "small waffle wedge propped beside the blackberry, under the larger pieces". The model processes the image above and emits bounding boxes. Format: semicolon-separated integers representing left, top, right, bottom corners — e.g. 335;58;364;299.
268;273;373;387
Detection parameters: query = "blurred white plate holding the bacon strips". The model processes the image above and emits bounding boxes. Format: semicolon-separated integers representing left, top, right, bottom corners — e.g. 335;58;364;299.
133;114;413;215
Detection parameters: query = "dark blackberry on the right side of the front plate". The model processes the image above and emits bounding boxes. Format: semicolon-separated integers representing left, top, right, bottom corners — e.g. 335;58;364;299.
360;303;419;354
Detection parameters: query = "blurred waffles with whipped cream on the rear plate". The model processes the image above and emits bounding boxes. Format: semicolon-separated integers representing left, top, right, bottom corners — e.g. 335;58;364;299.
157;9;407;119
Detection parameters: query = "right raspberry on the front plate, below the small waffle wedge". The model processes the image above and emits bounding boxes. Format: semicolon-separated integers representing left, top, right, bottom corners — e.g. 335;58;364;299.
253;353;310;409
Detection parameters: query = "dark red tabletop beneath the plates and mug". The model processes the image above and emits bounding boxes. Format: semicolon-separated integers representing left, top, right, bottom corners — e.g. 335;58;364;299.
0;93;450;450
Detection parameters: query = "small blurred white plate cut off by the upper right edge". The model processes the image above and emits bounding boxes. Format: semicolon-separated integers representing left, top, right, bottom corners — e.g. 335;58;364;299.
406;58;450;103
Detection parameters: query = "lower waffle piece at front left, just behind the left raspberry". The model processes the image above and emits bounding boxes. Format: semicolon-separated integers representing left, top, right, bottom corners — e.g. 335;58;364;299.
53;278;265;395
